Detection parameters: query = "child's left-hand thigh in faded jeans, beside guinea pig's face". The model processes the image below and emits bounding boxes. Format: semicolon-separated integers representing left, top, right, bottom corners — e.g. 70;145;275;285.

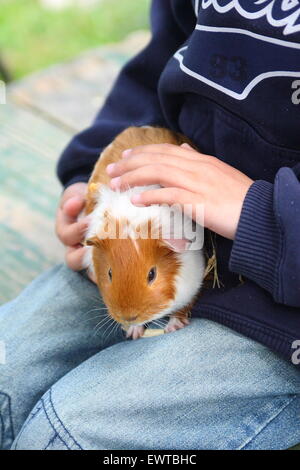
0;265;123;444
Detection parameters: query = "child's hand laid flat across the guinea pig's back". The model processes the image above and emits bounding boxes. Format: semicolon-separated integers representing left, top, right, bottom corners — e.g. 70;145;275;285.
107;144;253;240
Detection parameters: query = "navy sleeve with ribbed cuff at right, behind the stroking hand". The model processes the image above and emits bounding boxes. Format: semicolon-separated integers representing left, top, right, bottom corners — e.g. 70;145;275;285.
229;165;300;307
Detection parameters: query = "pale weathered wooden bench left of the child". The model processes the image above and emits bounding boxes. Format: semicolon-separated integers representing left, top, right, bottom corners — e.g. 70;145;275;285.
0;31;149;304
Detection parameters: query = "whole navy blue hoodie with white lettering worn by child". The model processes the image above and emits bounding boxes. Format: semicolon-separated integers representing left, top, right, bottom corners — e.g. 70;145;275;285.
58;0;300;365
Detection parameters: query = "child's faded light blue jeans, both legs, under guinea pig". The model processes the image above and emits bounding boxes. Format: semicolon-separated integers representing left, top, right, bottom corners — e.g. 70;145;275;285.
0;265;300;450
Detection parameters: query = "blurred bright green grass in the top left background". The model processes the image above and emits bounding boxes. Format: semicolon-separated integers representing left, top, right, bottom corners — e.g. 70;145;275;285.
0;0;150;79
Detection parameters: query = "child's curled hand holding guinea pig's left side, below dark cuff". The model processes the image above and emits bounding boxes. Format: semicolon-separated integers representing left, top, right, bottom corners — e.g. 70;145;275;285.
56;183;94;280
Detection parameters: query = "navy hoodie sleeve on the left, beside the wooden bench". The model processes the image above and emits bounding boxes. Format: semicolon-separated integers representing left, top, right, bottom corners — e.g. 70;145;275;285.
57;0;186;187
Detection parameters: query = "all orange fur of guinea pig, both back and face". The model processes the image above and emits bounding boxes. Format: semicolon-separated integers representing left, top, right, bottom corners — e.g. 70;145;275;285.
85;127;197;326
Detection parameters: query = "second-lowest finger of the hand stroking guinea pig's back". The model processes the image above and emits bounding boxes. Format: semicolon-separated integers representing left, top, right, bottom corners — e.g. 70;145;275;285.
110;164;196;191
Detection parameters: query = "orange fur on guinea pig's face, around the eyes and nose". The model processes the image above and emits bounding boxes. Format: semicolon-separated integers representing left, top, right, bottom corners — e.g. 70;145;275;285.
89;221;179;324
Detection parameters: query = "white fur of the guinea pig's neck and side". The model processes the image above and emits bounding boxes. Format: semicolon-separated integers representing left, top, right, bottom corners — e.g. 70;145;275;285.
85;185;205;320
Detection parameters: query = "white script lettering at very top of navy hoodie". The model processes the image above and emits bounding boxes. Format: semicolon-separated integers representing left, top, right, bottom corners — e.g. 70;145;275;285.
194;0;300;35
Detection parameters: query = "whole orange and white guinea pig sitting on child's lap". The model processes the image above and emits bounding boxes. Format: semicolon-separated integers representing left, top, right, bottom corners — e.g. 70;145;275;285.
85;127;205;339
